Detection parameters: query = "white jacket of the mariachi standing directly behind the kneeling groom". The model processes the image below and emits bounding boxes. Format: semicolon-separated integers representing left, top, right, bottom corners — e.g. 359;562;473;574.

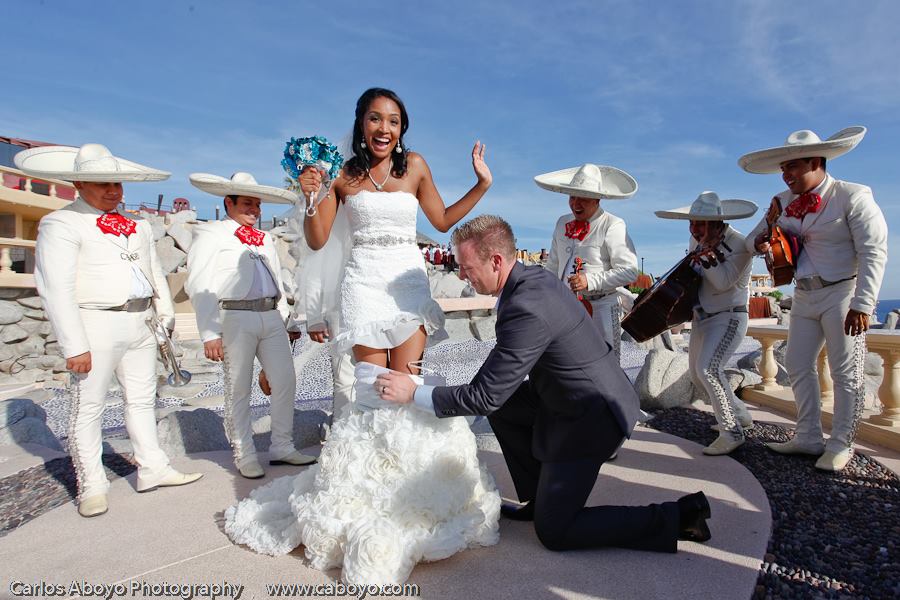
544;207;638;294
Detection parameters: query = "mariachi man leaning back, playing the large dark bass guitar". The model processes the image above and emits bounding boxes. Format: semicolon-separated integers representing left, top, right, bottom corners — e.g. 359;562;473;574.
656;192;757;455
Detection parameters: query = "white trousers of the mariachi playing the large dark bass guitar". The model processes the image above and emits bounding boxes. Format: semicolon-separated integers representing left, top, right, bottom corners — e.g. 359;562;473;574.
688;312;748;437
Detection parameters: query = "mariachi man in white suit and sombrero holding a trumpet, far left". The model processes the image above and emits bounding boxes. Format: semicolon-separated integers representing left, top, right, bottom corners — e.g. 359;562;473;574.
15;144;202;517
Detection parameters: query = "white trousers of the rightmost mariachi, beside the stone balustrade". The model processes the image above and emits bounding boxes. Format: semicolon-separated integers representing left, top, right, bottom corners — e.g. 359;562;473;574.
784;279;866;452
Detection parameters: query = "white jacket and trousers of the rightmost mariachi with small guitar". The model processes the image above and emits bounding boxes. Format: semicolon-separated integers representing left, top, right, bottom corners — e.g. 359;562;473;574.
747;175;887;452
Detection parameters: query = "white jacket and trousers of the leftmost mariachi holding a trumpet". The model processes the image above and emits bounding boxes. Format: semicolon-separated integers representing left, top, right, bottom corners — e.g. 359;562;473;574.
34;198;174;499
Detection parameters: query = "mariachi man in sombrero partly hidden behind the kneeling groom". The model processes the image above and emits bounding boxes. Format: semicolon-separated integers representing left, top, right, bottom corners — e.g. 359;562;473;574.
534;163;638;356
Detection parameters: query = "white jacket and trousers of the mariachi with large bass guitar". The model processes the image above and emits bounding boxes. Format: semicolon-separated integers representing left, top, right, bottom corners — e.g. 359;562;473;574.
688;225;753;437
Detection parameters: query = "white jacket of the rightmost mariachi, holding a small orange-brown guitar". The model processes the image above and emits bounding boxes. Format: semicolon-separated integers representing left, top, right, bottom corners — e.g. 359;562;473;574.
747;175;888;314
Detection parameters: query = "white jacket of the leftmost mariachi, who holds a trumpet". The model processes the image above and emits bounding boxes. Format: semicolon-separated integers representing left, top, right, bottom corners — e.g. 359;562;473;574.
34;198;175;358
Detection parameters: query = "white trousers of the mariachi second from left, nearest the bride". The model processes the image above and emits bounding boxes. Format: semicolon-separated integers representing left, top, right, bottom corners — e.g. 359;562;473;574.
221;310;297;467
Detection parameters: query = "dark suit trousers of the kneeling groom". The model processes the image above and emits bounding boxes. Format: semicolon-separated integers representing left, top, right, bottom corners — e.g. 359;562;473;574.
488;381;679;552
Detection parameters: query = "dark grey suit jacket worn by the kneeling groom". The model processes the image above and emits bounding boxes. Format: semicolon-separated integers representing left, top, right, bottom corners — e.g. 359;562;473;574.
432;263;640;461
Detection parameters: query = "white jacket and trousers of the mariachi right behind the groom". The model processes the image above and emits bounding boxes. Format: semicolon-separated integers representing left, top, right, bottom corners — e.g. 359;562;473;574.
544;207;638;355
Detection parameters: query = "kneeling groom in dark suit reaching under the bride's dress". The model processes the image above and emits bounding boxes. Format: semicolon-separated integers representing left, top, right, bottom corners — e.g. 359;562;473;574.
375;215;710;552
